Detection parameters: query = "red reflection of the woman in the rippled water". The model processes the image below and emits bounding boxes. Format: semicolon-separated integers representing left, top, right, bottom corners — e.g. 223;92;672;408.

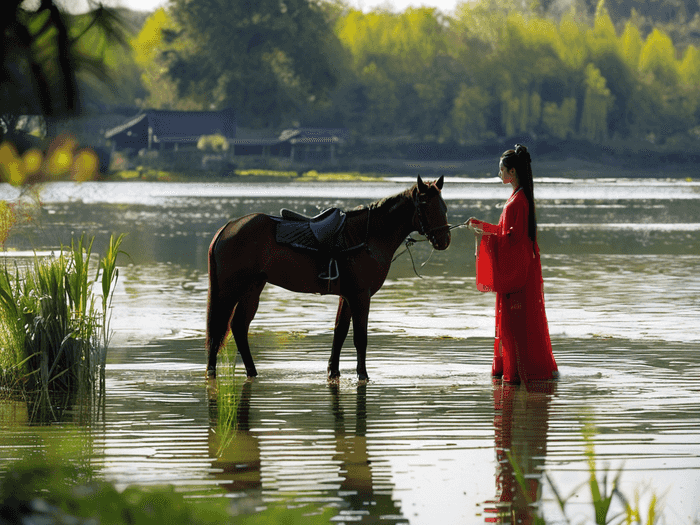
485;381;556;525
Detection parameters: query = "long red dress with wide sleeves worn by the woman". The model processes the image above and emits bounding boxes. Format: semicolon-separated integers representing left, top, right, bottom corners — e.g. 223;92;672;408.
476;189;557;383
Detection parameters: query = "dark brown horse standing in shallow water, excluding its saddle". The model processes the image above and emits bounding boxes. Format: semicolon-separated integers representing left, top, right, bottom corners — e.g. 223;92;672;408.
206;175;450;381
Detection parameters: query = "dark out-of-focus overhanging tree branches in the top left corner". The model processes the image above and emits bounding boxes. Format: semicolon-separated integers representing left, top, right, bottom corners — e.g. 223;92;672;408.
0;0;131;140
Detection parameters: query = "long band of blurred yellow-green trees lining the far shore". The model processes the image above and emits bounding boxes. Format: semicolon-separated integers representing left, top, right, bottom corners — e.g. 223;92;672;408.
132;0;700;144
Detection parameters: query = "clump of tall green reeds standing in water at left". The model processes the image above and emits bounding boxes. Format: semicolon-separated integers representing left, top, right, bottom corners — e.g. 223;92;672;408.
0;236;123;420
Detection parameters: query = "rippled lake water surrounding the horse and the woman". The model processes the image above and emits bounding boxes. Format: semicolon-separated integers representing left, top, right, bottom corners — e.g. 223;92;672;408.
0;178;700;524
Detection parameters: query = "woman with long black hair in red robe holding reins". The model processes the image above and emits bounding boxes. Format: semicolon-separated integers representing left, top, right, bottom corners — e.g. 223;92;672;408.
468;144;558;383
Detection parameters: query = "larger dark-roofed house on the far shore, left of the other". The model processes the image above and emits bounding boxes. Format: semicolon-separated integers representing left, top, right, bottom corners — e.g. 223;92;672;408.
105;109;236;153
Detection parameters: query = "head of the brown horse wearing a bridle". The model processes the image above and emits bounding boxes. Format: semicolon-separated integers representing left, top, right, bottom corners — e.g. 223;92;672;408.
413;175;450;250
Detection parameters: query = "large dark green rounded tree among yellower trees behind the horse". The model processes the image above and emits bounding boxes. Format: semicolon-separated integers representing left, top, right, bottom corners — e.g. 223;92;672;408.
163;0;338;126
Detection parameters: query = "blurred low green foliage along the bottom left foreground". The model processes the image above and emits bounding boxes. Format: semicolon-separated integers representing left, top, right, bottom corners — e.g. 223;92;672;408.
0;459;334;525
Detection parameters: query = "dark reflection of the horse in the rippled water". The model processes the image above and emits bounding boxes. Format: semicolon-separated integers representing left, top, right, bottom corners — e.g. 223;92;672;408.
209;380;408;524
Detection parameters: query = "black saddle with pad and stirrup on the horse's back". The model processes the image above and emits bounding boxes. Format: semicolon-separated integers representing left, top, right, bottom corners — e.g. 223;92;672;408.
274;208;345;281
